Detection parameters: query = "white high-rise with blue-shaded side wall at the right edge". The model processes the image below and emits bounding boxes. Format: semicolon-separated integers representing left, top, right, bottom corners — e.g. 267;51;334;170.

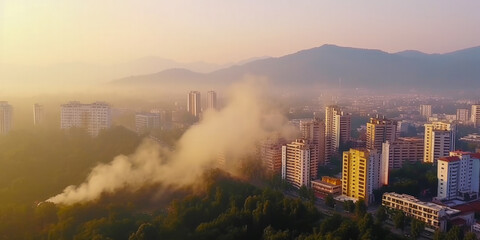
437;151;480;200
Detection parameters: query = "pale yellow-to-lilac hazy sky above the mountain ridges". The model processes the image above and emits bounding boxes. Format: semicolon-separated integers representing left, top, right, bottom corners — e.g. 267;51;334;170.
0;0;480;65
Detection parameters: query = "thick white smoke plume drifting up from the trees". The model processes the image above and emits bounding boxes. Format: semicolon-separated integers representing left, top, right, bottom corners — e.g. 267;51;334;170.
47;79;291;204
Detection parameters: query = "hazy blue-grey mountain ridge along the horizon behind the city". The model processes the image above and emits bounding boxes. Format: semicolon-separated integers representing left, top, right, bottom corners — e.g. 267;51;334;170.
113;45;480;89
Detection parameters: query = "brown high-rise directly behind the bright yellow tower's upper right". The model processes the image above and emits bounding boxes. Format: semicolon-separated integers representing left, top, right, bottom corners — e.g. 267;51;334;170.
367;118;398;151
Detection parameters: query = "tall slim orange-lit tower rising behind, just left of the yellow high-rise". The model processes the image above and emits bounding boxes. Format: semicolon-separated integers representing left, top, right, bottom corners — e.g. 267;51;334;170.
325;106;352;163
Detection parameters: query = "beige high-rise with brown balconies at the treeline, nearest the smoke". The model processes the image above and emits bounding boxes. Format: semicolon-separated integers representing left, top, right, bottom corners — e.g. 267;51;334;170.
282;139;311;188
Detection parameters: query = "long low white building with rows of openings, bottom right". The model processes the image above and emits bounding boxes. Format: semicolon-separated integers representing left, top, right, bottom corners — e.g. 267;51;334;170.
382;192;461;232
